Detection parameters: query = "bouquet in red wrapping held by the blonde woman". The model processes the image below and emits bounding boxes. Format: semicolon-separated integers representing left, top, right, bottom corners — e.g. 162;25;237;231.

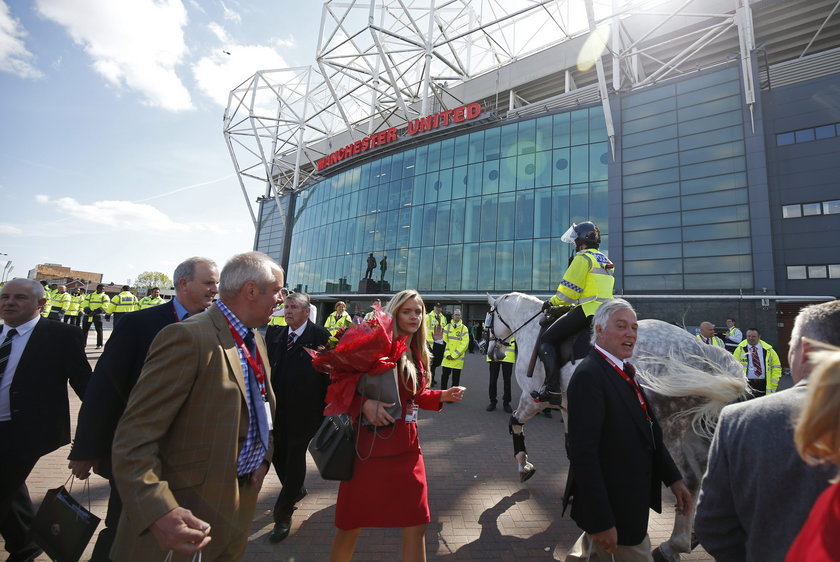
306;305;407;416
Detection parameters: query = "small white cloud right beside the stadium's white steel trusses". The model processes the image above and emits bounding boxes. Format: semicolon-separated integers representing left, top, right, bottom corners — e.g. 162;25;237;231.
192;23;288;107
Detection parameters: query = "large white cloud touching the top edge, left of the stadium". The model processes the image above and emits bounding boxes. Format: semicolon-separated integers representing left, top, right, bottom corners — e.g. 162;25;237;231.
36;0;192;111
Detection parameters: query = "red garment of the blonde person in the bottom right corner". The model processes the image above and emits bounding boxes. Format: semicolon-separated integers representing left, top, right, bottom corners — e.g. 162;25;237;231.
785;484;840;562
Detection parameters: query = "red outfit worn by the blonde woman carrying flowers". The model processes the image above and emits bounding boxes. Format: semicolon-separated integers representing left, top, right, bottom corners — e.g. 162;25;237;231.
335;358;442;530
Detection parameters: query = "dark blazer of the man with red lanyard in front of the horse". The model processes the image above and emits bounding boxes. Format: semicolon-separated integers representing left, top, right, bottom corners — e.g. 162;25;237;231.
568;349;681;546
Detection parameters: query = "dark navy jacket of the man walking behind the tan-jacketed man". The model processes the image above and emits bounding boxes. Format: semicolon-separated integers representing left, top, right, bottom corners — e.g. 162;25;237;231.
69;301;177;475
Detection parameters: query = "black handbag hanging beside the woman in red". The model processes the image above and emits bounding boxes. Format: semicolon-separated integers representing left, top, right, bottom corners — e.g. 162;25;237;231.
309;414;356;480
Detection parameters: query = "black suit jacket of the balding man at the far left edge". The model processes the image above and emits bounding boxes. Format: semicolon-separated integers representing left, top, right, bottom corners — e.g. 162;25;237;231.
3;318;90;460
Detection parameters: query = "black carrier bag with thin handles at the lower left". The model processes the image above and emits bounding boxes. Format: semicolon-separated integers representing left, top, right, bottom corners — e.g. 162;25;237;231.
30;479;100;562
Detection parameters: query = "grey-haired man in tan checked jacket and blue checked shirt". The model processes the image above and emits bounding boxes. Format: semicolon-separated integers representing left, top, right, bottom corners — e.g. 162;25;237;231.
111;252;283;562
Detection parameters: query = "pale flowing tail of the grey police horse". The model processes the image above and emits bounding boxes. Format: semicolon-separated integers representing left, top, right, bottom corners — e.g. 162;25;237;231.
638;349;749;439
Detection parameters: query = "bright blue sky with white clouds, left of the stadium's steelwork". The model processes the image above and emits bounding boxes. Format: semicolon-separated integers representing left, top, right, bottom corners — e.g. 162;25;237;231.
0;0;322;283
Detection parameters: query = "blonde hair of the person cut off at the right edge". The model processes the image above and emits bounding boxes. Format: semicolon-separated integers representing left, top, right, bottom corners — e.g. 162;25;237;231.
795;344;840;481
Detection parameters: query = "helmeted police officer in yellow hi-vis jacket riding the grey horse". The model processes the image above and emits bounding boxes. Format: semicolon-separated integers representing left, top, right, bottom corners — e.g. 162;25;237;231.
539;221;615;406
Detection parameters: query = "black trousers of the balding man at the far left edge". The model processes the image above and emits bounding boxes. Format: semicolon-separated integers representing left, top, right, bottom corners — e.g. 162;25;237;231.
0;422;38;559
